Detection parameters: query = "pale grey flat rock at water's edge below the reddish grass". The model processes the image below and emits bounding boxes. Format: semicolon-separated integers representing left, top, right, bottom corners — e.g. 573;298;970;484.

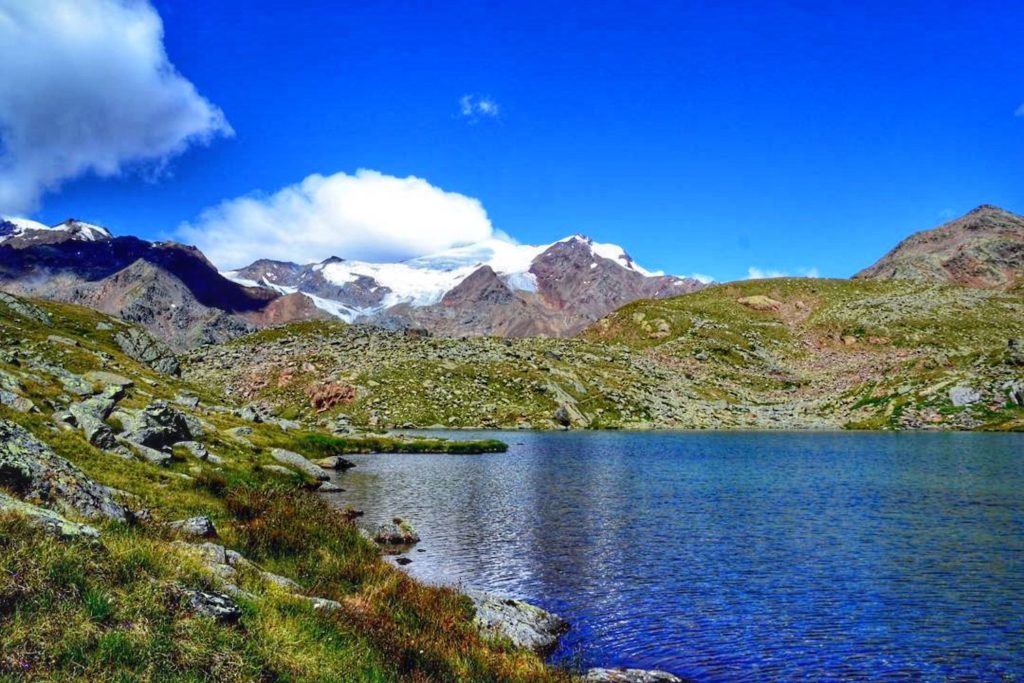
466;591;569;654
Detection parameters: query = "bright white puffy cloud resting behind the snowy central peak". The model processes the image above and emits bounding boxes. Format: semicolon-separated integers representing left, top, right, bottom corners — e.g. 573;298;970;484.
179;169;506;268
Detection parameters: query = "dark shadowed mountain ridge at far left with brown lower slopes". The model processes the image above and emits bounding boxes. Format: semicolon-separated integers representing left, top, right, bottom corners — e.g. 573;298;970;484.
0;219;323;349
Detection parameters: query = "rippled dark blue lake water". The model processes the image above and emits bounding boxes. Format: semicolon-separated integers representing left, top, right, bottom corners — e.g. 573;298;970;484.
327;432;1024;681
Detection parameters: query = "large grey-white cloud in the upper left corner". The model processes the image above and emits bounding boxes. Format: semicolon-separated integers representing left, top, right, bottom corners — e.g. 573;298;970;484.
0;0;232;213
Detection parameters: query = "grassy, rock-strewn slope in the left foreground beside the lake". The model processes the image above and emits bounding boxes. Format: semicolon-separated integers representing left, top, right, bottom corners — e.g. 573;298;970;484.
0;300;563;681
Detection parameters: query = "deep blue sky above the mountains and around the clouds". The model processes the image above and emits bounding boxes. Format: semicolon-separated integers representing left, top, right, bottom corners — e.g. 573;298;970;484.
8;0;1024;281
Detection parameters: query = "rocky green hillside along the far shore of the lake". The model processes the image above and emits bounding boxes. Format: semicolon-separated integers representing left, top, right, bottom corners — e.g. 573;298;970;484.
185;279;1024;429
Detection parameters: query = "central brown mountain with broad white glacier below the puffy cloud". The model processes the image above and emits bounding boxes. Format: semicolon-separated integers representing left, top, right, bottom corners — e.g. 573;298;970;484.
223;234;702;335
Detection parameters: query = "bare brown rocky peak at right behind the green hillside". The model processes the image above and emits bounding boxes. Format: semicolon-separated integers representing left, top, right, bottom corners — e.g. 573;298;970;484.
854;205;1024;289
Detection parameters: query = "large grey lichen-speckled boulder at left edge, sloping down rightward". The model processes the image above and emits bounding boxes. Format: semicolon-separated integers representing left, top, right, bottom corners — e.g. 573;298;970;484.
0;420;131;522
